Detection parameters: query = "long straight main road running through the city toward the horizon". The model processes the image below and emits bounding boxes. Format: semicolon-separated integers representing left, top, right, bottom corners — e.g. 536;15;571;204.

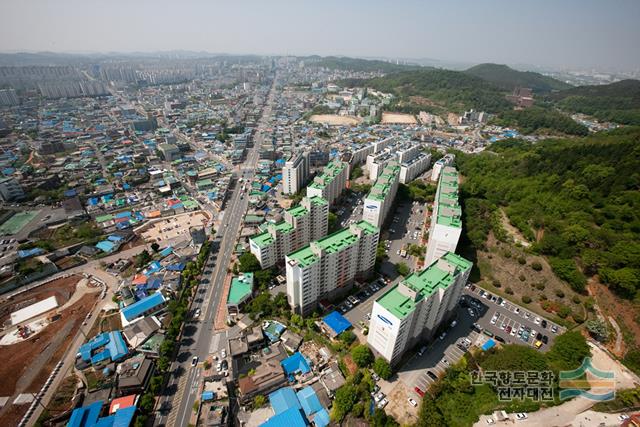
155;72;277;426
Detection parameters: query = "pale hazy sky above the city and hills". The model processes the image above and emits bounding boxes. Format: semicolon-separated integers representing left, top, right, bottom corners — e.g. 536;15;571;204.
0;0;640;69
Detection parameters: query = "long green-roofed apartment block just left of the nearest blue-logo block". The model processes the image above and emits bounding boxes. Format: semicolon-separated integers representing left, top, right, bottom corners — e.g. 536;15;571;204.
286;221;380;315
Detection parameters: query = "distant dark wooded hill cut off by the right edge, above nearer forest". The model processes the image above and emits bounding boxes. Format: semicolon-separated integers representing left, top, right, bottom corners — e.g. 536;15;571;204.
548;80;640;125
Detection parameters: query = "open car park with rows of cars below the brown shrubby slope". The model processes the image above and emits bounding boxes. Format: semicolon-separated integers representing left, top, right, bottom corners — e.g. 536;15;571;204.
462;284;565;351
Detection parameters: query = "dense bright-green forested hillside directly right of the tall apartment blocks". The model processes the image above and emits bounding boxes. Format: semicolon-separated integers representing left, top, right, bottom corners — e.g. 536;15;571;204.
458;127;640;298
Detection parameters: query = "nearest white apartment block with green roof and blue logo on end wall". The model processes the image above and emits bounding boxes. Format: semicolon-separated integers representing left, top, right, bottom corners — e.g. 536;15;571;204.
367;252;472;364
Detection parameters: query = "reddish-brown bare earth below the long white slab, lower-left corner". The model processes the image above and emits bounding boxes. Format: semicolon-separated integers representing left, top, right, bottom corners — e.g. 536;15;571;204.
0;292;99;426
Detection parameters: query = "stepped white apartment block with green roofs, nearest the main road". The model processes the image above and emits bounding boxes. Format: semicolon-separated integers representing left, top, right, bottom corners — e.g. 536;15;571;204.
249;197;329;268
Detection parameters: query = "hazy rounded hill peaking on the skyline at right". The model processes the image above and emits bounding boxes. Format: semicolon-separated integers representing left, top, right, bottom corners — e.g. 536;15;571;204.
465;64;571;93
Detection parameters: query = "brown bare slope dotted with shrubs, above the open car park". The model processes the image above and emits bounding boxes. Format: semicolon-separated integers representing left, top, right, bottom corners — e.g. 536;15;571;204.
478;234;586;320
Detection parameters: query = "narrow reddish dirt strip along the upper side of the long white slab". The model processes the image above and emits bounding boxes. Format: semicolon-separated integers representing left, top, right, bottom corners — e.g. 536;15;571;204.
0;275;82;324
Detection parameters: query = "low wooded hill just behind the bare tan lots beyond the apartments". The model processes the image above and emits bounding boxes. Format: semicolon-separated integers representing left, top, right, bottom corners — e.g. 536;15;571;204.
362;69;510;113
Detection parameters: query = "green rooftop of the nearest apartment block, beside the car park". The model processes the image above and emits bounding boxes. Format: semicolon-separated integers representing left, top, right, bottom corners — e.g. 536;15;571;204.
376;252;472;319
